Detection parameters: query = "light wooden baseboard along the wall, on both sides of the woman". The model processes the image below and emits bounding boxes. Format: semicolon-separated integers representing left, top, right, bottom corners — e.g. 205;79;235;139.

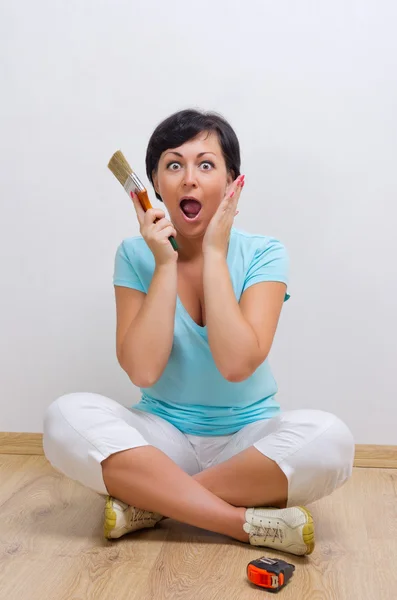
0;432;397;469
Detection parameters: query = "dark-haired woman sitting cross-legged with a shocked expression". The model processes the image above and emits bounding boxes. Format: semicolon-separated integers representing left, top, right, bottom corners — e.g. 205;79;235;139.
44;110;354;554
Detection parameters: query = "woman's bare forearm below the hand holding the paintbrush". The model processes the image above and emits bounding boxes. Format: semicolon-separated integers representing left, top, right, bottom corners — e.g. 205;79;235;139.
121;263;177;387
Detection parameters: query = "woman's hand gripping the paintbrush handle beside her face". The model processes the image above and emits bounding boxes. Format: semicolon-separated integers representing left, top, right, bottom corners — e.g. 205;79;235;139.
131;194;178;266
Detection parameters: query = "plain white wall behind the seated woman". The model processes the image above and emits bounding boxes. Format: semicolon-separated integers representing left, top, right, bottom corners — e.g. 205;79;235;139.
0;0;397;444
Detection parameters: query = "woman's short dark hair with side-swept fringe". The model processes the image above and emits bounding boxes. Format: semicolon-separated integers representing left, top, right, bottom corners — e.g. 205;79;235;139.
146;109;241;201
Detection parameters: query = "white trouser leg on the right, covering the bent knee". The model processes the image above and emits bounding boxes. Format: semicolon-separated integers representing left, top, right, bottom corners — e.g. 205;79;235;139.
208;409;355;506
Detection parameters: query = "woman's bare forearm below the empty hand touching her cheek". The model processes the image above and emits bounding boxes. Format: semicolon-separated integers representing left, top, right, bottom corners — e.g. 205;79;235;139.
203;253;258;381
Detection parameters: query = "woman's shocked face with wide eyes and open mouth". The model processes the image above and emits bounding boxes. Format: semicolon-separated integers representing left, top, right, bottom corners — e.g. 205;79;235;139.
153;131;233;237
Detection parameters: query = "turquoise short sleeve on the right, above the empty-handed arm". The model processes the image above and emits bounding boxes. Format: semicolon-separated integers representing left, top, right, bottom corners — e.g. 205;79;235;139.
243;238;290;301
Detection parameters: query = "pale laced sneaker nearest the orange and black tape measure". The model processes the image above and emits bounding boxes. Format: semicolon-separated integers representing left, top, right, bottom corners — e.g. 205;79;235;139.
243;506;314;555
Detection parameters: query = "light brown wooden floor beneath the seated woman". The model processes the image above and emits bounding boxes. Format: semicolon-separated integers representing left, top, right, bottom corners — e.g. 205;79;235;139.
0;455;397;600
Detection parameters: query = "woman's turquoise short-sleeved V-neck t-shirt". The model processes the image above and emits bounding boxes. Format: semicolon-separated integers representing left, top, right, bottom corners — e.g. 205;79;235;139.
113;228;289;436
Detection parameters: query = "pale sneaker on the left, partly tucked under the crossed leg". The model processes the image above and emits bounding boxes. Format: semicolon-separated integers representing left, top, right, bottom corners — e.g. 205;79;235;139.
103;496;163;540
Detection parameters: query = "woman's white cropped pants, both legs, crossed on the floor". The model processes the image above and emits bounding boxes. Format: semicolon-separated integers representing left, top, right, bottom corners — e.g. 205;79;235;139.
43;392;354;508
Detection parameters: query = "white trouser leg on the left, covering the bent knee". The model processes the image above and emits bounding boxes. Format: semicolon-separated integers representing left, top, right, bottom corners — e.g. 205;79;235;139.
43;392;200;495
